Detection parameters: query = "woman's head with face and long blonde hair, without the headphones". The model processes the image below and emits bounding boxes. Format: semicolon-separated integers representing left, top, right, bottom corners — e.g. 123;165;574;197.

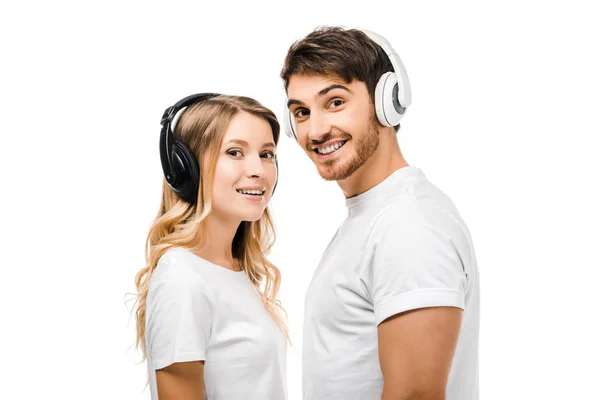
136;95;285;360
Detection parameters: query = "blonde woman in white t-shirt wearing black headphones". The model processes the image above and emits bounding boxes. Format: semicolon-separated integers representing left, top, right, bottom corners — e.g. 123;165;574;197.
136;94;287;400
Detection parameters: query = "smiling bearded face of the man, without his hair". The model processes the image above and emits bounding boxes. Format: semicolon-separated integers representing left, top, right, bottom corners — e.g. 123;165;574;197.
287;75;379;181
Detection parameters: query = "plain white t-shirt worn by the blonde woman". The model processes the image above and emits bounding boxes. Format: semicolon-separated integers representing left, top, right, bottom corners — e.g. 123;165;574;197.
146;248;287;400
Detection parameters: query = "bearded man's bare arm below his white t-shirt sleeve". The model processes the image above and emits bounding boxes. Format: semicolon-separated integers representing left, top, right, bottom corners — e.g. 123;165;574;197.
378;307;462;400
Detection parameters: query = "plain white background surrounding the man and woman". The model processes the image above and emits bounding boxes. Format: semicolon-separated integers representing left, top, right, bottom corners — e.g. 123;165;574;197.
0;0;600;400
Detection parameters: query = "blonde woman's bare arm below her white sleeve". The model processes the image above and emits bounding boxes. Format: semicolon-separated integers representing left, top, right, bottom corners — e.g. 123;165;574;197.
156;361;204;400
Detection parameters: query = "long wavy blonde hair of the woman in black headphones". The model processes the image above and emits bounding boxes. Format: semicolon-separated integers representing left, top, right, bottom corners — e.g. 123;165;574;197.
135;95;289;360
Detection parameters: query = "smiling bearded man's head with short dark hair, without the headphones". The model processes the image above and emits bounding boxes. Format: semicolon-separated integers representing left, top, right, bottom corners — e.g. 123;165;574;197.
281;27;410;180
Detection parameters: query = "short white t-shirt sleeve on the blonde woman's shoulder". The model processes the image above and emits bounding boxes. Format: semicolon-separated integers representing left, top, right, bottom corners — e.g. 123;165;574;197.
146;262;213;370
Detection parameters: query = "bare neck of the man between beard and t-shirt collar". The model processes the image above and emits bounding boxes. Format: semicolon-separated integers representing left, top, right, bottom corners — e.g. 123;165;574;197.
337;131;408;199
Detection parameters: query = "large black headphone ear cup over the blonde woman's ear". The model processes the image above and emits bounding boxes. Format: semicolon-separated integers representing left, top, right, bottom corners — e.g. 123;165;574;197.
173;140;200;204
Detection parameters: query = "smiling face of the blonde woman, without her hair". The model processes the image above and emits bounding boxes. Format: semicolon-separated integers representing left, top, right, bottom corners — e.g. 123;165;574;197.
212;111;277;225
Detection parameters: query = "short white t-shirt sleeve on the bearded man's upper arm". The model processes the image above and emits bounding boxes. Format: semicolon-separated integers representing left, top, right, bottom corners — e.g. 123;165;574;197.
362;200;467;325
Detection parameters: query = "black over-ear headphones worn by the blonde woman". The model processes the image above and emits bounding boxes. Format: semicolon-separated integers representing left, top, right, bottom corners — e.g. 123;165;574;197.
160;93;279;204
